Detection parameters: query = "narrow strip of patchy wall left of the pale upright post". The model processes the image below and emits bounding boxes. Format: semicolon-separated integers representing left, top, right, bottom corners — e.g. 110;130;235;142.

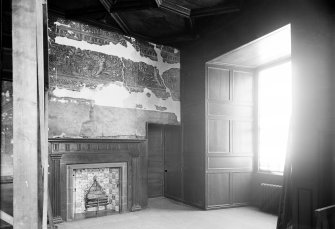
1;81;13;180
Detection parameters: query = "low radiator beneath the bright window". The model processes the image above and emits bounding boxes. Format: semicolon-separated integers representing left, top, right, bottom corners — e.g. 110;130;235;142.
260;183;283;214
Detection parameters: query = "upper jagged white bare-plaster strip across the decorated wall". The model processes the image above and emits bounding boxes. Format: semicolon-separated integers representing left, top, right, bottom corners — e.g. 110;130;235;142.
55;36;180;75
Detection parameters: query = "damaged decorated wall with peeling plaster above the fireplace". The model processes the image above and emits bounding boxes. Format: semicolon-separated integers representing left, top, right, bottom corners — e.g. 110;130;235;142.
49;16;180;138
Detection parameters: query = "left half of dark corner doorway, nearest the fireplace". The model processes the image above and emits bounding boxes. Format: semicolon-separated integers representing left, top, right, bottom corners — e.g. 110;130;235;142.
148;124;164;197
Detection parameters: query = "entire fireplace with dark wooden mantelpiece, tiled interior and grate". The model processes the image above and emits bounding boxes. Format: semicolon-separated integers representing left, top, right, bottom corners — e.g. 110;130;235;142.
49;139;147;223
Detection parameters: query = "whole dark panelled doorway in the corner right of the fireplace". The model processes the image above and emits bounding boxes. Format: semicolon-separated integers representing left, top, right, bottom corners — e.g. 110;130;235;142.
147;123;182;200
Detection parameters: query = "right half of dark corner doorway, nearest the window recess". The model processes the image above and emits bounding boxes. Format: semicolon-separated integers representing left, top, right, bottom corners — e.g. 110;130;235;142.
164;126;182;200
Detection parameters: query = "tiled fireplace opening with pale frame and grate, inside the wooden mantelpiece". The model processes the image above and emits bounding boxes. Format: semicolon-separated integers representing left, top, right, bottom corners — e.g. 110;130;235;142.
67;162;128;220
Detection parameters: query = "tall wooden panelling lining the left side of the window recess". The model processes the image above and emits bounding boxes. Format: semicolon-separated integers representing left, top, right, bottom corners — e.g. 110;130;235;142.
206;65;254;208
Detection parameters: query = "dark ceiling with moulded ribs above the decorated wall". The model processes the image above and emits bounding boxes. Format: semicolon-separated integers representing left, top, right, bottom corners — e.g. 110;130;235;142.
48;0;244;44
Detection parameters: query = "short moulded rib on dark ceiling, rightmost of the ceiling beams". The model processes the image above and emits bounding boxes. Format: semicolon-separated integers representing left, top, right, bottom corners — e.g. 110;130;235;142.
190;5;240;18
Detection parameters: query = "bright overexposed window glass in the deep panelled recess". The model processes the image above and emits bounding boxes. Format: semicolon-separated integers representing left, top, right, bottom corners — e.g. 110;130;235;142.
258;62;292;173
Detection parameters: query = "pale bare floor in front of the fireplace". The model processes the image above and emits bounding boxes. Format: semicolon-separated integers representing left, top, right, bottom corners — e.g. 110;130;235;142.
58;197;277;229
